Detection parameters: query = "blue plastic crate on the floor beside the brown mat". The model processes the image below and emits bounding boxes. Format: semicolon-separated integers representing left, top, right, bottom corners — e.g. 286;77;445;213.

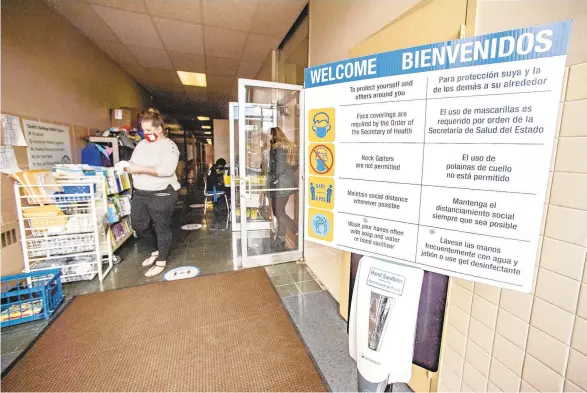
0;269;64;328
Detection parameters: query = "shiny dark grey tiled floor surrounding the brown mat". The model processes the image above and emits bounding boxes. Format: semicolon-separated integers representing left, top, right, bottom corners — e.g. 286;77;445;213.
0;191;342;391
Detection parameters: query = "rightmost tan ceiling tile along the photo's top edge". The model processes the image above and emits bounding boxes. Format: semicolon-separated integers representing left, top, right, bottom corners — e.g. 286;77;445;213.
251;0;307;40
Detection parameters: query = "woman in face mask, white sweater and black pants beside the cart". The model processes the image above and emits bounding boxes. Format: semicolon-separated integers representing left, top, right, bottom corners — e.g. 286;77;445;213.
126;109;181;277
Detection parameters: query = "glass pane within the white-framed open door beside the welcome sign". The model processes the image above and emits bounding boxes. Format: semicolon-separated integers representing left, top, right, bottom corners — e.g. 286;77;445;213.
241;86;301;256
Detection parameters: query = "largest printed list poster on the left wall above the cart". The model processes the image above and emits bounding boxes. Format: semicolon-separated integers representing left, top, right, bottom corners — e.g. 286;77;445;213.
23;120;71;169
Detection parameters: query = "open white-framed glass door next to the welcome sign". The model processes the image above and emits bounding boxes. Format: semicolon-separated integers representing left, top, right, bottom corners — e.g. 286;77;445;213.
237;79;304;267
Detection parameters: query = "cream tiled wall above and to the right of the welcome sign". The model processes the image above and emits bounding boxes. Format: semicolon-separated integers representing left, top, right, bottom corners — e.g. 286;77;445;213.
439;0;587;392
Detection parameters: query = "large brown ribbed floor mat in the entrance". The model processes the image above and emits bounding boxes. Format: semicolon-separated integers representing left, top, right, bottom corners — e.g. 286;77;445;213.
2;269;326;392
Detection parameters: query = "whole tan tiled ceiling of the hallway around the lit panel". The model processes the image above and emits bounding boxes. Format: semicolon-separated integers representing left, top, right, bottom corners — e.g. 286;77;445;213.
45;0;307;124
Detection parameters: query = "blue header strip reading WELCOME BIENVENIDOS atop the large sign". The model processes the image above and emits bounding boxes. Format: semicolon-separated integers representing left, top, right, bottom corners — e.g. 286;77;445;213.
304;21;572;88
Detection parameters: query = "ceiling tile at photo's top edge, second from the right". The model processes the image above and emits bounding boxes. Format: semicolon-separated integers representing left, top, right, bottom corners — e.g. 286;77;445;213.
203;0;258;32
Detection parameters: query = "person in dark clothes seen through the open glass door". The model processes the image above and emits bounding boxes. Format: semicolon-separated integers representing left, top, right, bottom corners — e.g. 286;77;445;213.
267;127;299;250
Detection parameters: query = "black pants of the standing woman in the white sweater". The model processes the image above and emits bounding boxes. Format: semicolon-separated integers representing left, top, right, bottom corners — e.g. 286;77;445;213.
131;186;177;261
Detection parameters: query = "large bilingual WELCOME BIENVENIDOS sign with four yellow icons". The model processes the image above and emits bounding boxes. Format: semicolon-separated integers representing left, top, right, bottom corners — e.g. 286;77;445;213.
305;22;571;291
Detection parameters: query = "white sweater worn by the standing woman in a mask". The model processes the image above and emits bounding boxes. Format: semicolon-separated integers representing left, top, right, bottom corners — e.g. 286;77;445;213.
130;138;181;191
